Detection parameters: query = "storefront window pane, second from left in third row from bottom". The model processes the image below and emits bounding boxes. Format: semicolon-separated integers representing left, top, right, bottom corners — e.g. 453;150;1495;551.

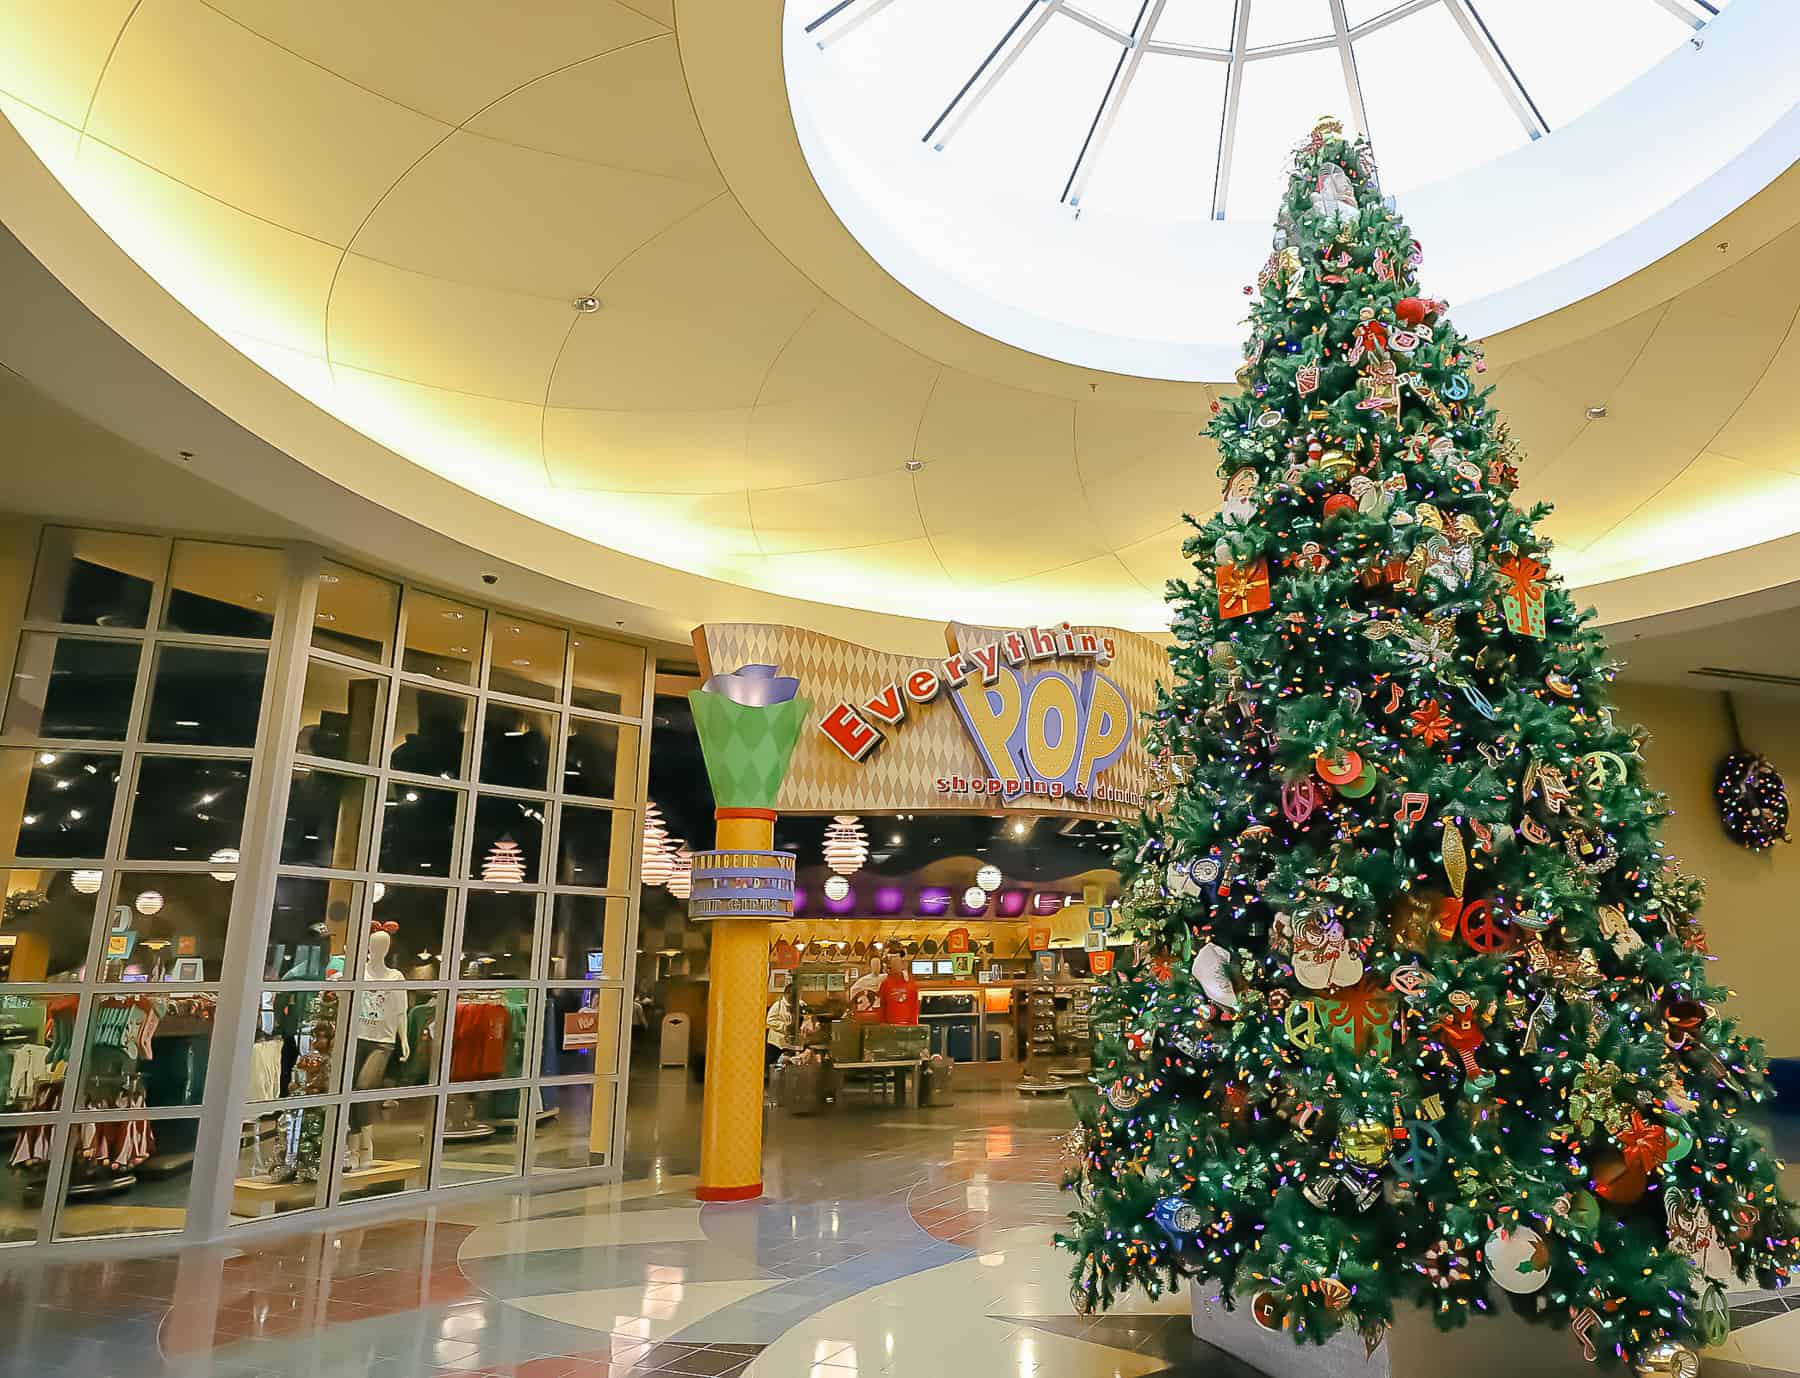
101;871;236;984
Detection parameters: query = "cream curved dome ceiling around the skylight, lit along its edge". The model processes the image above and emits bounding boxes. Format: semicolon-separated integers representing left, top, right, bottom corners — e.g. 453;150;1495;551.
0;0;1800;628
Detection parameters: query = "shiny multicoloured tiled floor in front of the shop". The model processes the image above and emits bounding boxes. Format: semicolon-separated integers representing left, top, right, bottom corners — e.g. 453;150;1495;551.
0;1069;1800;1378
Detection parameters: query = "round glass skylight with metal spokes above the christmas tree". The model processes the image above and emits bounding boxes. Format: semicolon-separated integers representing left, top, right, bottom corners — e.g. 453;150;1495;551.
806;0;1726;221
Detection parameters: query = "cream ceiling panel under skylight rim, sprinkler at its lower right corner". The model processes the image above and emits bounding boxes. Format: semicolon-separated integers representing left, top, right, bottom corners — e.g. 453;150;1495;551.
749;302;938;500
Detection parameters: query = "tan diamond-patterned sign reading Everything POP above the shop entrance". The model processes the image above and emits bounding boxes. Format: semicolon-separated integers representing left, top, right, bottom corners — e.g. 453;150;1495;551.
693;622;1168;819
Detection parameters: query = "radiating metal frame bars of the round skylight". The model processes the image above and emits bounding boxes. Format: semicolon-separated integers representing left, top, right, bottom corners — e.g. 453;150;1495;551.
805;0;1719;219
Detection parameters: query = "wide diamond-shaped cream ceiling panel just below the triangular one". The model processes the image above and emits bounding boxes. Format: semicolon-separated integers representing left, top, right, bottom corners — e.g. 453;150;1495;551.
355;133;711;302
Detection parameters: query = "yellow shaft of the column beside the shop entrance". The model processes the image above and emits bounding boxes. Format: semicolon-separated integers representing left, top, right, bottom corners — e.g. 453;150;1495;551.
693;808;776;1202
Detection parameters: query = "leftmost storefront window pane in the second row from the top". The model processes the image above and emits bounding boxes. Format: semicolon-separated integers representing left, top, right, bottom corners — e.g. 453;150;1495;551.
5;631;142;741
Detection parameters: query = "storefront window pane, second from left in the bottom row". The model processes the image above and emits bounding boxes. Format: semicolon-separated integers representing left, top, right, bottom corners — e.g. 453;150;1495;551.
56;1115;200;1239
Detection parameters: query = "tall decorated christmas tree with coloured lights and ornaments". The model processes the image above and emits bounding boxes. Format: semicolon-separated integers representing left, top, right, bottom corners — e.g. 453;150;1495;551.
1058;121;1796;1365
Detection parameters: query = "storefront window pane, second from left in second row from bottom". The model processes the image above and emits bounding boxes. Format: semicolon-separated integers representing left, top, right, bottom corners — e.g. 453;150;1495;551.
81;991;218;1110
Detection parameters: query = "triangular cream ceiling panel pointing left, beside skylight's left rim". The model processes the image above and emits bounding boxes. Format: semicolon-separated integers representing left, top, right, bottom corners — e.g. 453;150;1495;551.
468;34;725;191
